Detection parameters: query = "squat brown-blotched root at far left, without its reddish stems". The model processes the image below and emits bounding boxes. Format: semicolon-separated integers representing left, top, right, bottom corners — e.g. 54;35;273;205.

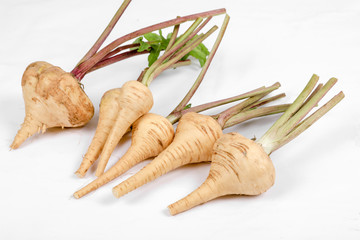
10;62;94;149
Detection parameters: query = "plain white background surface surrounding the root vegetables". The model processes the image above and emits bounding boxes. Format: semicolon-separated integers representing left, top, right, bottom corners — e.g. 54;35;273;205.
0;0;360;239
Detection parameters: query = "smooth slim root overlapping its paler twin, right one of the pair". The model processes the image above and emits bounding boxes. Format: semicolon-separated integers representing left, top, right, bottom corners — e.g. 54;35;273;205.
95;81;153;176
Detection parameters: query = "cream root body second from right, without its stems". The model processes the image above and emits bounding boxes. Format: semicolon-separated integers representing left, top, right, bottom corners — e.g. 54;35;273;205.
113;113;222;198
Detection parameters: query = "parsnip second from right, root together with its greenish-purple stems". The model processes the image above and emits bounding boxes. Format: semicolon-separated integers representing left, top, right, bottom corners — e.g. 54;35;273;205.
113;83;287;197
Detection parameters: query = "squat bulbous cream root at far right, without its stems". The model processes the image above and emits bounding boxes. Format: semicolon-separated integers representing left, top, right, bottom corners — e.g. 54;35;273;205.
169;133;275;215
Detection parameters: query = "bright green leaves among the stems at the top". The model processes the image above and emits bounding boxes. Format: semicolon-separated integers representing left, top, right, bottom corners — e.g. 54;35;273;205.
131;30;209;67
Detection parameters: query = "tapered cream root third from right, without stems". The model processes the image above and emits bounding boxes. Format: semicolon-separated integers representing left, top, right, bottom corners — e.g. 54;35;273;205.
74;113;174;198
